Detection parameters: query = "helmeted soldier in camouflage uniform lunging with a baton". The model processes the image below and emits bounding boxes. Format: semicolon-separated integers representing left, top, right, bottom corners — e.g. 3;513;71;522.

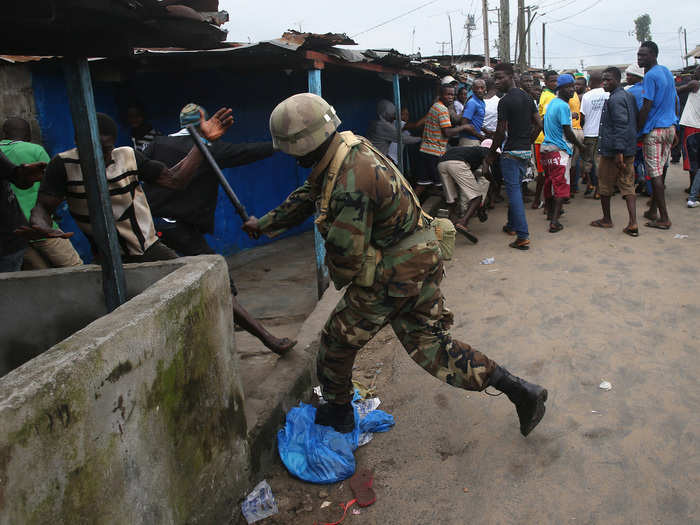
243;93;547;435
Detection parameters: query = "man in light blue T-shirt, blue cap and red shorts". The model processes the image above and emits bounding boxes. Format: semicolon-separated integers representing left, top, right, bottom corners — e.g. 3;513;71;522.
540;74;583;233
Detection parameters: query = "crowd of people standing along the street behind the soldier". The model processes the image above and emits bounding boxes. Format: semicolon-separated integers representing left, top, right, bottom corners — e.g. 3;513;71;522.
367;41;700;250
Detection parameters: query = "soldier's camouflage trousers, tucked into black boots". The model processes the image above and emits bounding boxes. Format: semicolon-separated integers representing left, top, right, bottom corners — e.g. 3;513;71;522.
316;263;497;404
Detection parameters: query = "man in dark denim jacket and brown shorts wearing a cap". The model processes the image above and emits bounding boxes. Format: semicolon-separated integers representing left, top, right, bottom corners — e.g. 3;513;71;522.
591;67;639;237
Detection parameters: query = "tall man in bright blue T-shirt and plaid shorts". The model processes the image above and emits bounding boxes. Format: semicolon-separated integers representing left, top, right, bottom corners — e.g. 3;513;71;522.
637;41;678;230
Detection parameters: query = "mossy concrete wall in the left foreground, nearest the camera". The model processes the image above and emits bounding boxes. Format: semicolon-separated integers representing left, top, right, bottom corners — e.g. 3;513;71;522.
0;256;249;525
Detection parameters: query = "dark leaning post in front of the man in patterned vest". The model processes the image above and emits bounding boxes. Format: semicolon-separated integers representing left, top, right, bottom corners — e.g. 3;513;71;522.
63;58;126;312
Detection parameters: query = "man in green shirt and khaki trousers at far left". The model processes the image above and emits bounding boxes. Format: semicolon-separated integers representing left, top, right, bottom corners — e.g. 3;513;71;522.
0;117;83;270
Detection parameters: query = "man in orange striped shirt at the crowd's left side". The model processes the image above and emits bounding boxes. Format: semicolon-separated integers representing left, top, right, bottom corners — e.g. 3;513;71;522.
416;84;466;196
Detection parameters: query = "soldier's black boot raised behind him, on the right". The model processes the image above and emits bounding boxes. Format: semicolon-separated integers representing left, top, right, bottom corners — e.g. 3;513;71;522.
489;366;547;436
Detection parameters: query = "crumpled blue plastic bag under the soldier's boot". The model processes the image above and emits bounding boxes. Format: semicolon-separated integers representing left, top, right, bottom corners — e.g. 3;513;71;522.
277;393;394;483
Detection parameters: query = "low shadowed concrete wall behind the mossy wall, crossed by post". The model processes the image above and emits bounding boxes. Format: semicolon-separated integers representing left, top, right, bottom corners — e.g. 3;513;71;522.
0;261;183;377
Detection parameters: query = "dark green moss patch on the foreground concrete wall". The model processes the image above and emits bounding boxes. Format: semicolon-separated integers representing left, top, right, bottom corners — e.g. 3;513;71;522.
147;282;246;519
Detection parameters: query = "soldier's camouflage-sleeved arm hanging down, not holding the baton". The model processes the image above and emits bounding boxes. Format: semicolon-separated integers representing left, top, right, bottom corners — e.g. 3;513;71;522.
326;191;374;290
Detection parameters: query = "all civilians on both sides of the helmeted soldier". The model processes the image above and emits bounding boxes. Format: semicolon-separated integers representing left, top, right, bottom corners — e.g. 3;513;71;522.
0;37;700;360
